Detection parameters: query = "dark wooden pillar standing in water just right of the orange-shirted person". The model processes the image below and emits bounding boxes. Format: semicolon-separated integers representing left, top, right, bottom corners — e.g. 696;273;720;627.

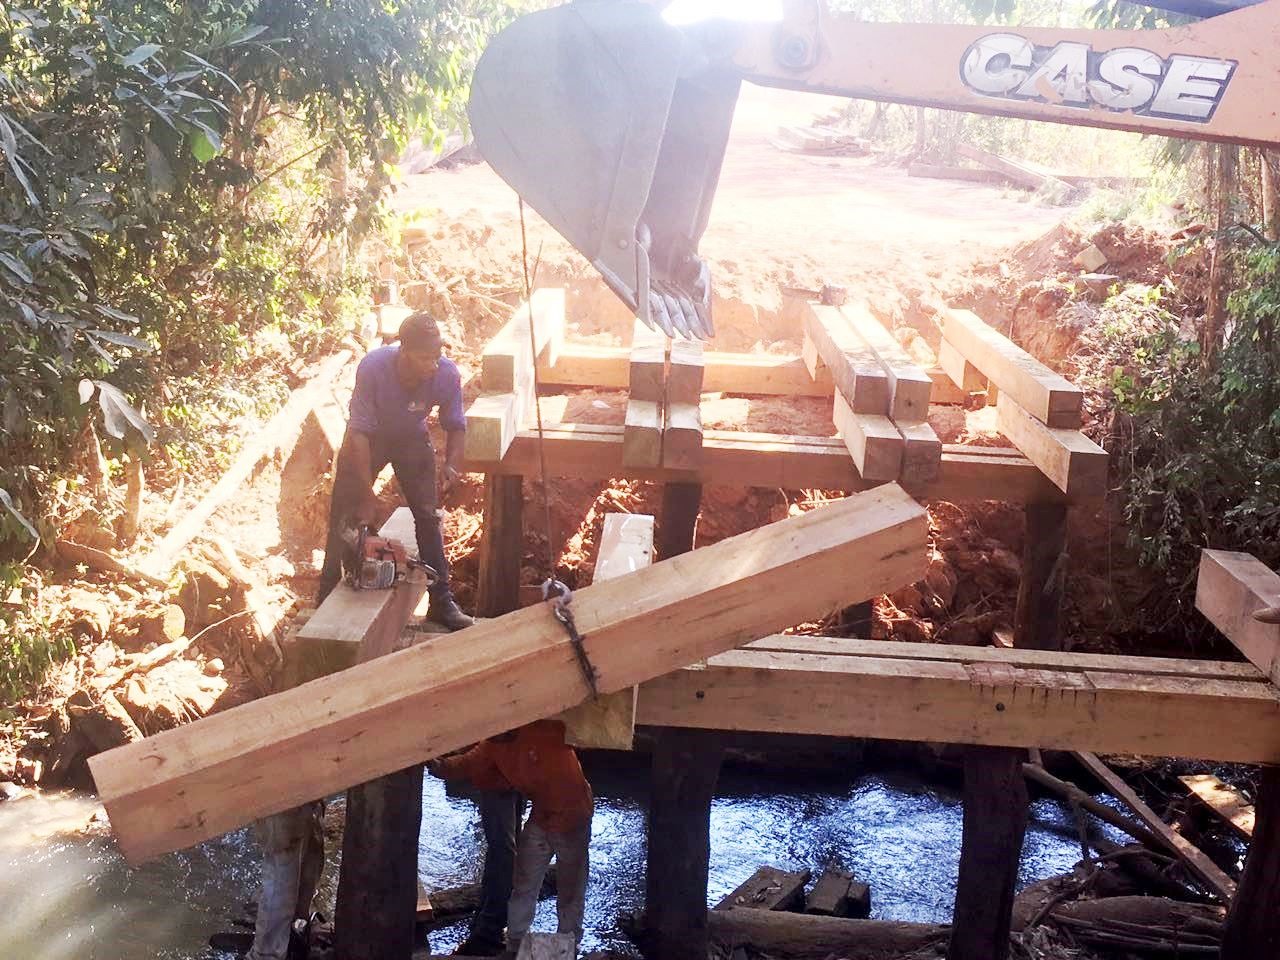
643;727;723;960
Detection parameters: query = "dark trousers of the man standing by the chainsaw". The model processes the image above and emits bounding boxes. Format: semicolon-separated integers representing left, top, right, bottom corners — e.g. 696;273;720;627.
316;434;452;603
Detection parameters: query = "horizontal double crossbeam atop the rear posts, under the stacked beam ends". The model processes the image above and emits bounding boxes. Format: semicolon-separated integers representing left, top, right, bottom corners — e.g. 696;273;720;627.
465;422;1071;503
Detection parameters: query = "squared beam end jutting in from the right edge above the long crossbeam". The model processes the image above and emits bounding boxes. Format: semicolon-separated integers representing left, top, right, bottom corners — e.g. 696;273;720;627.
1196;550;1280;685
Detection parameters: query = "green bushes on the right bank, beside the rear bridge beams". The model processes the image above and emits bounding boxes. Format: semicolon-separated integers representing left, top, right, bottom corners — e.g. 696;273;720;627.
1082;244;1280;619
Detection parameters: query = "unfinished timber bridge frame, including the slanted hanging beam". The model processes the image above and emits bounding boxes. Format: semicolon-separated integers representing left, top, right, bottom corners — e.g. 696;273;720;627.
93;291;1280;960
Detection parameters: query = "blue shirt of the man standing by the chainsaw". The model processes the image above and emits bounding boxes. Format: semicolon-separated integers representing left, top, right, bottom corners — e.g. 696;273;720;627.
348;343;467;438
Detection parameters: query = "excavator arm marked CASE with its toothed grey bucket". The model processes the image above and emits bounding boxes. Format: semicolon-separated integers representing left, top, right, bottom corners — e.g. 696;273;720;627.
470;0;1280;338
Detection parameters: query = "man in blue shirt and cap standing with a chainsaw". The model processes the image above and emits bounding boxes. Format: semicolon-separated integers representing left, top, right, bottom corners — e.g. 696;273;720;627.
319;312;472;630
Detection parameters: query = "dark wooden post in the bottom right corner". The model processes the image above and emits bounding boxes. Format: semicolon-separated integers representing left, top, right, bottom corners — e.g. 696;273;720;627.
1221;767;1280;960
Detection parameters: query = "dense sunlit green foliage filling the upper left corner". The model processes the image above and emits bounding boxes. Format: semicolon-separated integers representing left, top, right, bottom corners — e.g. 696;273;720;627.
0;0;508;556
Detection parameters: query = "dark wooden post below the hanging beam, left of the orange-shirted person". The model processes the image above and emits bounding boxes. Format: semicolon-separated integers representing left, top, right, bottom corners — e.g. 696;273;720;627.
334;764;422;960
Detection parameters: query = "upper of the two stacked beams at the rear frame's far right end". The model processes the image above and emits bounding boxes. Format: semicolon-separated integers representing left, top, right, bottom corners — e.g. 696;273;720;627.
937;306;1084;429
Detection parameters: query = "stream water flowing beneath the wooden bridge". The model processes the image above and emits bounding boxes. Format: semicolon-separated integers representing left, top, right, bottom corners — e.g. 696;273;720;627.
0;764;1121;960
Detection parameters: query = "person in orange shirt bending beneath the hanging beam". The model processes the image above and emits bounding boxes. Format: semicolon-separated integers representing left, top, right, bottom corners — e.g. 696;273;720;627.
428;719;595;955
